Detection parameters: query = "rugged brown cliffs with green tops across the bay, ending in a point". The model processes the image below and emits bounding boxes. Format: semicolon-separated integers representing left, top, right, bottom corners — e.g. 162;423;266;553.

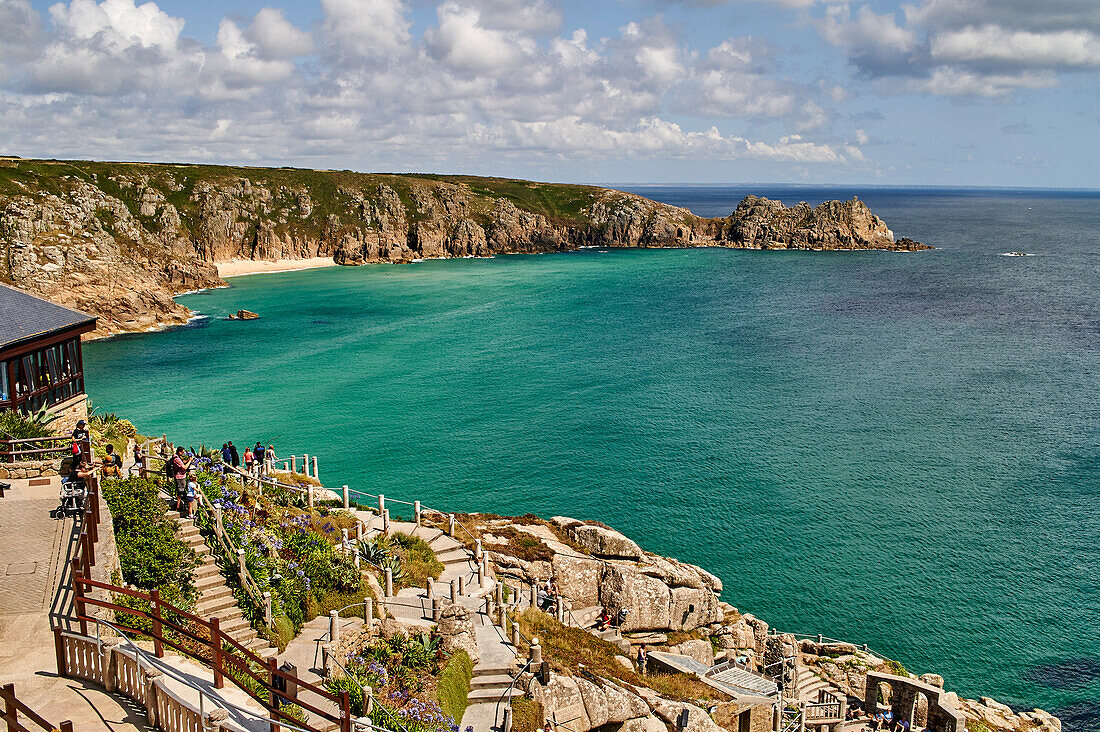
0;160;927;336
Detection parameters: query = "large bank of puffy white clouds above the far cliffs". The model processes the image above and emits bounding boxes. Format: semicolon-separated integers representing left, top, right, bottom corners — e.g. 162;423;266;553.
0;0;861;170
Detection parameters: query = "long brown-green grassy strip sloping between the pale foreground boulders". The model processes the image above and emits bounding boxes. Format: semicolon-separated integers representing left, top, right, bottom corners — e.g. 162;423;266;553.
519;610;726;701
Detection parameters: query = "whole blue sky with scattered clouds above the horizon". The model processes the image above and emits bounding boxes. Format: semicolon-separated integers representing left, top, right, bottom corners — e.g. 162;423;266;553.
0;0;1100;188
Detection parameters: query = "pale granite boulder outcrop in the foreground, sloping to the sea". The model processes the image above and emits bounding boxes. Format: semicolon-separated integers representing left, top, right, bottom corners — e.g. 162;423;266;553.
444;514;1062;732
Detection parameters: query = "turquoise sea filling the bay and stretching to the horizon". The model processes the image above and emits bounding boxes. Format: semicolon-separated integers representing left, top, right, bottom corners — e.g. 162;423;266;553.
85;189;1100;730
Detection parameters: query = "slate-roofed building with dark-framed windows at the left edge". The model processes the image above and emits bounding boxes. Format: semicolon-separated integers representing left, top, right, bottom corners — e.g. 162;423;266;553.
0;285;96;430
